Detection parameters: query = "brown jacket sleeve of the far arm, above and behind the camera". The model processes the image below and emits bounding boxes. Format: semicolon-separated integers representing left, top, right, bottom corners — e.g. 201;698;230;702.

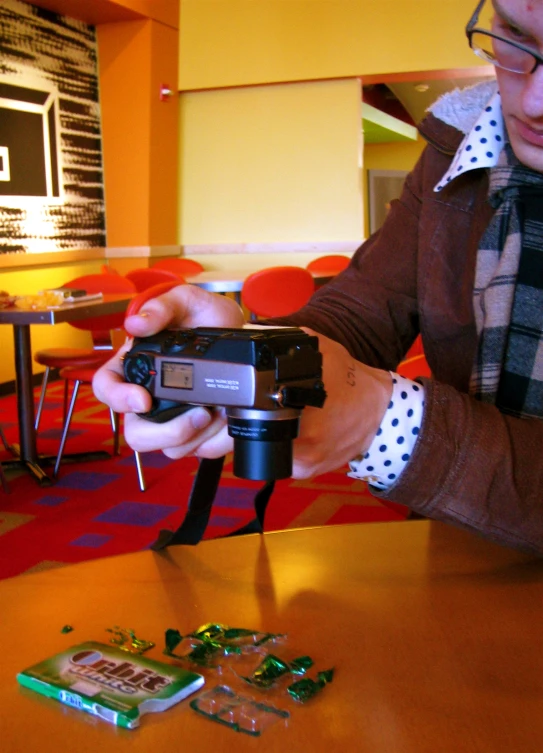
270;151;430;369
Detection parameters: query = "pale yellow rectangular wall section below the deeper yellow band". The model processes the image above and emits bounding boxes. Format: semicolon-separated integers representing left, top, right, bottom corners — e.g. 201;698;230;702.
179;79;363;244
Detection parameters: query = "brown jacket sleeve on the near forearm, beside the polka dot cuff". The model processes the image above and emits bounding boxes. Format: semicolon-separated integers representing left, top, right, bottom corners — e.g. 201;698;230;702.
382;379;543;555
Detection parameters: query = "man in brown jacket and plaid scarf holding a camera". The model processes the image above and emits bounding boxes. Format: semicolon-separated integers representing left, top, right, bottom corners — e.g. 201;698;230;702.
94;0;543;553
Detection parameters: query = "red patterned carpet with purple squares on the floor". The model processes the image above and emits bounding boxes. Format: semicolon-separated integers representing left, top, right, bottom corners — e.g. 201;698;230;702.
0;382;405;578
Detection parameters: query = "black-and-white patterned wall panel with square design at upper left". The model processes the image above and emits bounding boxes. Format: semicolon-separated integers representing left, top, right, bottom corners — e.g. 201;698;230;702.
0;0;106;253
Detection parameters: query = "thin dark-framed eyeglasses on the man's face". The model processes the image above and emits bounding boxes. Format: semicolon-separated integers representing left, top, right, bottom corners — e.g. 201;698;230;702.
466;0;543;73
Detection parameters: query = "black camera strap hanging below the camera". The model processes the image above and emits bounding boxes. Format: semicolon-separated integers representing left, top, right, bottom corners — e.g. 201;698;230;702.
151;457;275;552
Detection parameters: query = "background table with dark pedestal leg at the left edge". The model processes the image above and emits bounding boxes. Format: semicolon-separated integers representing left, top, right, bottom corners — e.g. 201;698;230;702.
0;293;131;486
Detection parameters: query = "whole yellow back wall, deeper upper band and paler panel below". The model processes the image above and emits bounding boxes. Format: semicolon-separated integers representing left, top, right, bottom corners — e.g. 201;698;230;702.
178;0;490;253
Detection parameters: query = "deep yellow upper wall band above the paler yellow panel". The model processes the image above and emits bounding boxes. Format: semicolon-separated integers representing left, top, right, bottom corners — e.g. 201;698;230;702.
179;0;488;90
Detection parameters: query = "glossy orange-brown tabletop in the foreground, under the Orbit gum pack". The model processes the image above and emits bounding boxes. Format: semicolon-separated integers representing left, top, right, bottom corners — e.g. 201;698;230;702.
0;520;543;753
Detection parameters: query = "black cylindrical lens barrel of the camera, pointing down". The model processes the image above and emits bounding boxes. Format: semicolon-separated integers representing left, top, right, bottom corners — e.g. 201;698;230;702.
227;408;301;481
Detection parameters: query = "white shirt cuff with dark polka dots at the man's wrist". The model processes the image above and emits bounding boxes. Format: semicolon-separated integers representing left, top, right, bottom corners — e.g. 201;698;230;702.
347;372;424;490
